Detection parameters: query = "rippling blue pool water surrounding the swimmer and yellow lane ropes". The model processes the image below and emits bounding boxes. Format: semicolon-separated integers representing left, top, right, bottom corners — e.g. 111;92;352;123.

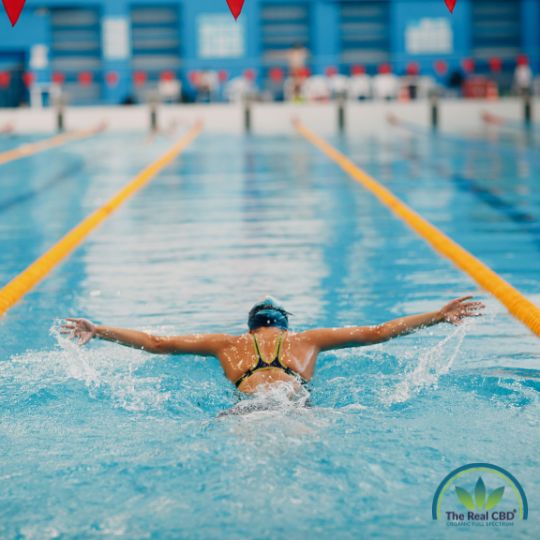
0;130;540;539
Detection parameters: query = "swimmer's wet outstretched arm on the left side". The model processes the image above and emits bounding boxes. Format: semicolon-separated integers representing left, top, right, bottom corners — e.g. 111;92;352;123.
61;319;231;356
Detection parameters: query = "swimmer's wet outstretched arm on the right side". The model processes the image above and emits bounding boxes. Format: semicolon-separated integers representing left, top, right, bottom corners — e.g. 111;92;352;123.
302;296;484;351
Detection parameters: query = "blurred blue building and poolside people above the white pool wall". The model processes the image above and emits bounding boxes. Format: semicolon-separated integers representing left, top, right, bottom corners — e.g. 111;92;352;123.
0;0;540;107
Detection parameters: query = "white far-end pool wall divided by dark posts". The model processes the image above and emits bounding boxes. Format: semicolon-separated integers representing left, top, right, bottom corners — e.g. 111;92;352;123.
0;98;540;135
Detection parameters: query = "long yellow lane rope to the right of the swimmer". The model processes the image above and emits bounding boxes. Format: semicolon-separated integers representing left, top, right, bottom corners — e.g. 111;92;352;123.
295;122;540;336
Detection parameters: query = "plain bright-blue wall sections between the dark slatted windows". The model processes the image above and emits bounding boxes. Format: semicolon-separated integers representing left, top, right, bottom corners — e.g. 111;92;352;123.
0;0;540;103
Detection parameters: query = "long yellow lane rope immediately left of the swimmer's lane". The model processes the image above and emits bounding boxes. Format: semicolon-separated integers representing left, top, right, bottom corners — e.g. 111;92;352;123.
0;123;202;316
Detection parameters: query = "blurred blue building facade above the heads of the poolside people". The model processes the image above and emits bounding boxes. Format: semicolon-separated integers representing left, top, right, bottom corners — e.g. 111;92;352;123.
0;0;540;106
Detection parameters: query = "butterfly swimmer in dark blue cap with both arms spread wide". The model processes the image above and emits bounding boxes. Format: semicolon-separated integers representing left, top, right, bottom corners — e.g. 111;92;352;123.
61;296;484;394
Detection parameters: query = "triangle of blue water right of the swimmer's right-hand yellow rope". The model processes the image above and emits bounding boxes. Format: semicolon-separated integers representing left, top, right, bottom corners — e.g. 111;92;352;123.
344;126;540;298
